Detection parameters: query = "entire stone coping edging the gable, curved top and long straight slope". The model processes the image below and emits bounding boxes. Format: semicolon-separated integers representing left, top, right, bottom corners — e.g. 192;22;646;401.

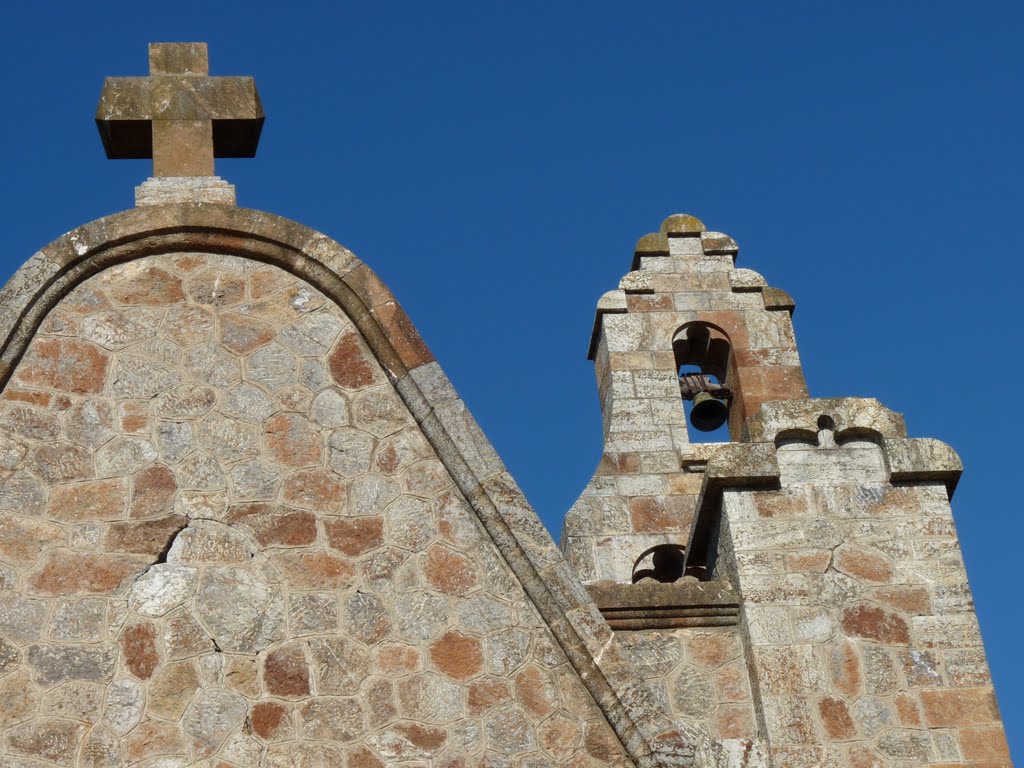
0;204;741;768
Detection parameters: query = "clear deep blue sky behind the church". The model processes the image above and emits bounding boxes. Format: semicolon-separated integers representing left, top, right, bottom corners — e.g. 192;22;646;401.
0;0;1024;761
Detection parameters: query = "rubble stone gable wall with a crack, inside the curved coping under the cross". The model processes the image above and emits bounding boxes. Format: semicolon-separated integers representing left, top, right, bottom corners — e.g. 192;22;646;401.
0;253;632;767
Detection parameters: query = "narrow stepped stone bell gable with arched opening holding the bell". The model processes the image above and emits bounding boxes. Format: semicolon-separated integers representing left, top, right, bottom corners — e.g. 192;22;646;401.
562;214;808;583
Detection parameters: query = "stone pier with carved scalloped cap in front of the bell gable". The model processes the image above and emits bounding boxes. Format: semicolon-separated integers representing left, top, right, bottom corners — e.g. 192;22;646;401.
721;399;1010;768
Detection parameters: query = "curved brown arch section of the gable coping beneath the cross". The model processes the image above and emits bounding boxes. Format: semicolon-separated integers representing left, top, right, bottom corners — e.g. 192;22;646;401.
0;205;433;386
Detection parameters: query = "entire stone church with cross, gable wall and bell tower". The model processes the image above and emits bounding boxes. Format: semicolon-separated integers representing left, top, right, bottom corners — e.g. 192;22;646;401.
0;44;1011;768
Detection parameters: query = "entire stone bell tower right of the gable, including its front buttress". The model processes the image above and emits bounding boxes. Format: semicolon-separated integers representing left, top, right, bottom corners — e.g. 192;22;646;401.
562;215;1011;768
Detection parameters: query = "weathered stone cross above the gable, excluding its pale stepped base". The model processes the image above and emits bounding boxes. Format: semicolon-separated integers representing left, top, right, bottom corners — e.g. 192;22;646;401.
96;43;263;176
